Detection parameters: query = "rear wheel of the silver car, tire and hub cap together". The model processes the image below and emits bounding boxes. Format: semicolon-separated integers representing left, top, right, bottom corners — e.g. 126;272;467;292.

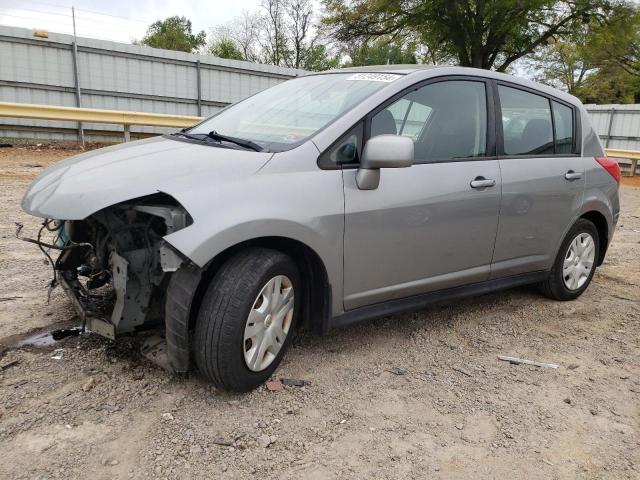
539;218;600;301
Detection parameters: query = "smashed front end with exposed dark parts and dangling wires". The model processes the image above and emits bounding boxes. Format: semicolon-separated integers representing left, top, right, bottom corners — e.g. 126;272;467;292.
19;193;192;339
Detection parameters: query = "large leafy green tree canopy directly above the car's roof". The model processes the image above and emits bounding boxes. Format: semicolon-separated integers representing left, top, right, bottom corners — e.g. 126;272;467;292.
323;0;624;71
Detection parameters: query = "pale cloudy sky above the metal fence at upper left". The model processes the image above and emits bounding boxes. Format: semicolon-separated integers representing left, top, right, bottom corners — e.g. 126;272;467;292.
0;0;260;42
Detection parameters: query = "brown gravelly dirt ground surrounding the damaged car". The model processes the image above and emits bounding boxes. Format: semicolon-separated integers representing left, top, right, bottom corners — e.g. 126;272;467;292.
0;146;640;480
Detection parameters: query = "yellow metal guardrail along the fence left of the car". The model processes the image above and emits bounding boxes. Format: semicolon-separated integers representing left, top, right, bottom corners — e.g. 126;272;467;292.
0;102;202;142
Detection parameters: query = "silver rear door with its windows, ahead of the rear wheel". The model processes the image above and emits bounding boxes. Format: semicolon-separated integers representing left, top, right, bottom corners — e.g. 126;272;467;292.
491;82;585;278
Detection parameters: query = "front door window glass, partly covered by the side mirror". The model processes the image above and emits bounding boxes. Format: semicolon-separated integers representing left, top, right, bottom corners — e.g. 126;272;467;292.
371;80;487;162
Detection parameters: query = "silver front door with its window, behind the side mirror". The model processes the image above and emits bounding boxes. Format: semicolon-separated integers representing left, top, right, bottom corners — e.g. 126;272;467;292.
344;79;501;310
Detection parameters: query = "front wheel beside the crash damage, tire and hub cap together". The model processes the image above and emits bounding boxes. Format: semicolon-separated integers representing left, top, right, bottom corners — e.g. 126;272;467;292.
194;248;302;392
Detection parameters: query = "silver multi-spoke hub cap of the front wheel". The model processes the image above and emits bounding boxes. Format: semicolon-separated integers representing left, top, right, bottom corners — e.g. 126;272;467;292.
244;275;294;372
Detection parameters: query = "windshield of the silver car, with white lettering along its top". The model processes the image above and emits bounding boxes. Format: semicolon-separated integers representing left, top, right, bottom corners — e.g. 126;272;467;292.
188;73;400;151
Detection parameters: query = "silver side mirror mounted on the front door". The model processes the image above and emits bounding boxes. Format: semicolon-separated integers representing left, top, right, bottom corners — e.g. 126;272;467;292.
356;135;413;190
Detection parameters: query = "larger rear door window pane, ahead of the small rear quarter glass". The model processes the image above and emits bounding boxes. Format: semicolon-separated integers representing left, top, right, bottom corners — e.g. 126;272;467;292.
498;85;554;155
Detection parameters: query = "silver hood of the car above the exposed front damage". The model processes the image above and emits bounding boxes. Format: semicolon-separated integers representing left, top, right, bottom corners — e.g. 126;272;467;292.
22;137;273;220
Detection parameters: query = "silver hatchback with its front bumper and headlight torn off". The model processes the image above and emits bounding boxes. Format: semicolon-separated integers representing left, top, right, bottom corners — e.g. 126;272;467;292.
22;66;620;391
